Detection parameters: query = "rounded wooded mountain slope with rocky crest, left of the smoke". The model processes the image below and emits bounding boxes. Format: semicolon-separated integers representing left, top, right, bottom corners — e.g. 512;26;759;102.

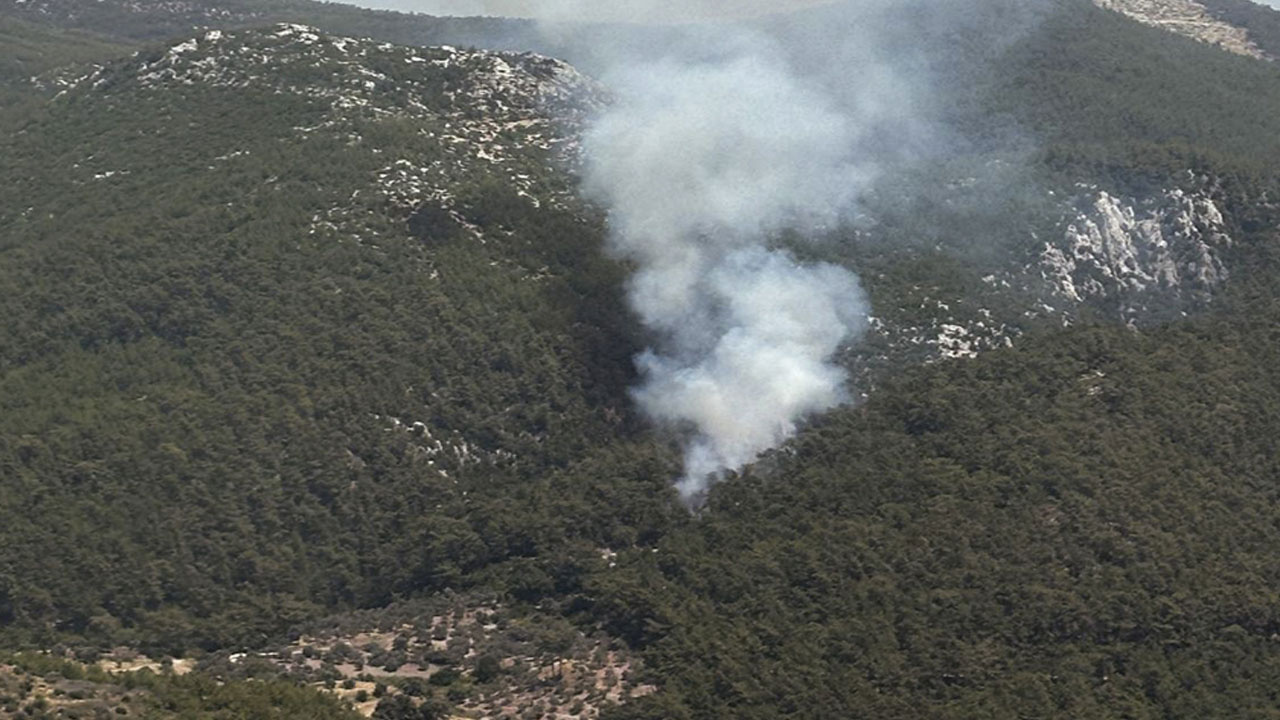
0;26;660;648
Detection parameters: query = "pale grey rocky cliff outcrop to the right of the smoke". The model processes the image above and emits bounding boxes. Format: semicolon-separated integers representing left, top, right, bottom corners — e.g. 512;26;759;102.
855;178;1234;382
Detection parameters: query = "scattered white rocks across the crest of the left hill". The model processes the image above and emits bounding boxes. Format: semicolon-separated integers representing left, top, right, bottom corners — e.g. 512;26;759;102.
48;23;604;238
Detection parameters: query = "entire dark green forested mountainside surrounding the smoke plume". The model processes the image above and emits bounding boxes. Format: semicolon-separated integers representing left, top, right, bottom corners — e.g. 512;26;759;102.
0;0;1280;719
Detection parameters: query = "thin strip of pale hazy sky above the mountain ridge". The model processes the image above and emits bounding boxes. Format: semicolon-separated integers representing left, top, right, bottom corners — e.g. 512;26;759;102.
348;0;832;22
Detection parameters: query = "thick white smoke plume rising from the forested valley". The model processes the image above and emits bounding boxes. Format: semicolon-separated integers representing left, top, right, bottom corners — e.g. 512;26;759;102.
555;3;911;502
